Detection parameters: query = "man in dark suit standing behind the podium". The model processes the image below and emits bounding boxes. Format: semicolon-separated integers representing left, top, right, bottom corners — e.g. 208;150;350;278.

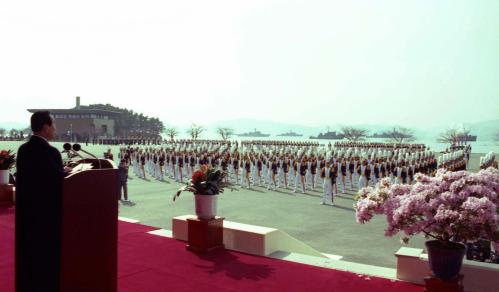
16;111;69;292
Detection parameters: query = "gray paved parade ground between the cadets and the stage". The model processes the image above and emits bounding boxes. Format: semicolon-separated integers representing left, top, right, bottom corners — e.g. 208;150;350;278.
0;142;481;268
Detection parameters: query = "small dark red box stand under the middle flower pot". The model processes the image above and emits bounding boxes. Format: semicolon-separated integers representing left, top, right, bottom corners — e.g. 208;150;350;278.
187;217;225;253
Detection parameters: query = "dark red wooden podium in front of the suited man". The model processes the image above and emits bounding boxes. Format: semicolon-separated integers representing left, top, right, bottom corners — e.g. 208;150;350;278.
60;159;119;292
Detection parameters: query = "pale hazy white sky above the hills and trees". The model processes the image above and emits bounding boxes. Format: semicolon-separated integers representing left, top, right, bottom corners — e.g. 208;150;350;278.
0;0;499;126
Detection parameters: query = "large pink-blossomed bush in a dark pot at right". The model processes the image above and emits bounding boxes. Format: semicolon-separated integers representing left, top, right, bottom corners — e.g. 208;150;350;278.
354;168;499;280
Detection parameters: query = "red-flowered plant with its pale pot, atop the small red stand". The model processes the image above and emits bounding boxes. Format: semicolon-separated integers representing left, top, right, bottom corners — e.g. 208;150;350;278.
173;166;232;220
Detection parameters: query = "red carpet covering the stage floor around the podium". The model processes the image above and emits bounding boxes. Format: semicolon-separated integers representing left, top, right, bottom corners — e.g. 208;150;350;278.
0;209;423;292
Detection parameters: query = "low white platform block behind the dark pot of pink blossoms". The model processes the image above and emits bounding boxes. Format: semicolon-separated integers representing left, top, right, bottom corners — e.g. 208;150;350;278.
395;247;499;292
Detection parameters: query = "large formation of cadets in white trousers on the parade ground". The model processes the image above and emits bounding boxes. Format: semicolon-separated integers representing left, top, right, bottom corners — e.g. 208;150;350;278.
119;140;437;204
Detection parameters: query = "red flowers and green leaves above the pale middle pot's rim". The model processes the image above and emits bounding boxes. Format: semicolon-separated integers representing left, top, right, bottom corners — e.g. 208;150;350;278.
173;166;233;201
